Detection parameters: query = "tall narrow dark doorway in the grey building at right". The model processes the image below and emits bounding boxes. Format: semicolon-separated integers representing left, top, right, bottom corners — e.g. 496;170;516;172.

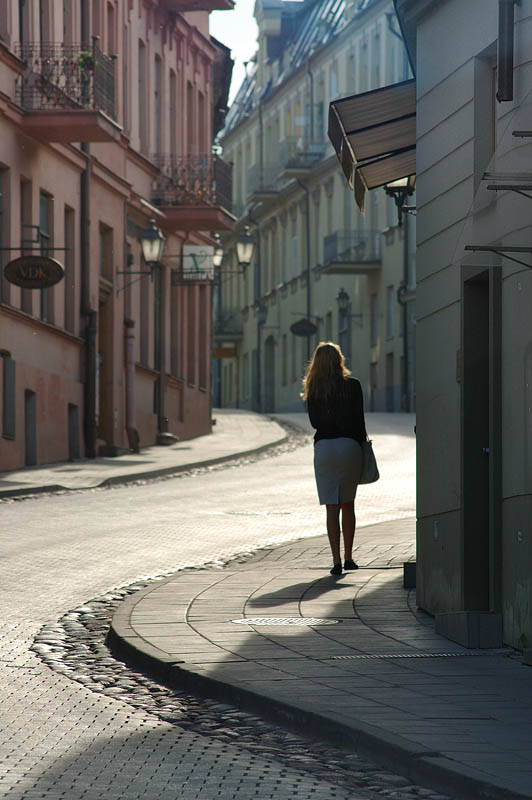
460;270;492;611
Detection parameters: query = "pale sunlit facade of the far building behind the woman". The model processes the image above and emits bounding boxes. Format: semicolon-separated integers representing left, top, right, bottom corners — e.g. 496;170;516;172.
215;0;415;412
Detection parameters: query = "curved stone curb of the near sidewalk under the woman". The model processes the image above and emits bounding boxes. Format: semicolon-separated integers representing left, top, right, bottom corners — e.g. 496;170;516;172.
106;578;532;800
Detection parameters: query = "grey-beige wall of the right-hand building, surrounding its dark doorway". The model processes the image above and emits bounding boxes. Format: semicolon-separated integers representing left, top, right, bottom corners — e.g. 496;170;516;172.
417;0;532;646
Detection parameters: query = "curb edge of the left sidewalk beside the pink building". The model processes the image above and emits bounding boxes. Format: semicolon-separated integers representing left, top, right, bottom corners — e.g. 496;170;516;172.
0;435;288;500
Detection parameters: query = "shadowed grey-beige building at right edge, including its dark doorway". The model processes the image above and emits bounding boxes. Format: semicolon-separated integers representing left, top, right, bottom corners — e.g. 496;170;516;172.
396;0;532;648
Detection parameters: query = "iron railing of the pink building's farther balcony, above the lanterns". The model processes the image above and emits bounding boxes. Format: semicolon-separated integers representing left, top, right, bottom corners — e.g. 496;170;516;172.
152;154;233;211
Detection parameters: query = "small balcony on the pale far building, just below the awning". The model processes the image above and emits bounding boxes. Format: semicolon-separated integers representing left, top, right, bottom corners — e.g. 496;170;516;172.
321;230;382;275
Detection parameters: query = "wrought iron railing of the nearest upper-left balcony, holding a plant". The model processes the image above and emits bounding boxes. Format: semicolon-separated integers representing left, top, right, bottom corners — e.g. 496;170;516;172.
15;42;115;119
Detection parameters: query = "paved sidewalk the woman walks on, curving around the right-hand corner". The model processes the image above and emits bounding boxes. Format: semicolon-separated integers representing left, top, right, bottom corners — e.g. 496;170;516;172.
108;519;532;800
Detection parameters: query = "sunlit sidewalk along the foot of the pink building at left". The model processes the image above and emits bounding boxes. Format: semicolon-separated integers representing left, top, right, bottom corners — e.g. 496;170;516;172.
0;408;286;498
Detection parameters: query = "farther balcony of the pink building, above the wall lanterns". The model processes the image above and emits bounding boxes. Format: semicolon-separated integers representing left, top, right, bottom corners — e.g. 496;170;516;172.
152;155;236;231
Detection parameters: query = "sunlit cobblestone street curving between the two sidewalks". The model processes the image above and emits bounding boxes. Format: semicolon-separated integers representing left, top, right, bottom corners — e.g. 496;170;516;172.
0;415;422;800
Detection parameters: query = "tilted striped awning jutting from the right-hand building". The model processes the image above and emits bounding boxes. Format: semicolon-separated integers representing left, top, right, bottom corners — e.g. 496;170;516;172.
328;78;416;210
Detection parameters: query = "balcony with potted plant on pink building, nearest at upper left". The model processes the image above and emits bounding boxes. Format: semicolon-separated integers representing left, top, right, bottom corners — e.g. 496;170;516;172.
15;42;121;143
